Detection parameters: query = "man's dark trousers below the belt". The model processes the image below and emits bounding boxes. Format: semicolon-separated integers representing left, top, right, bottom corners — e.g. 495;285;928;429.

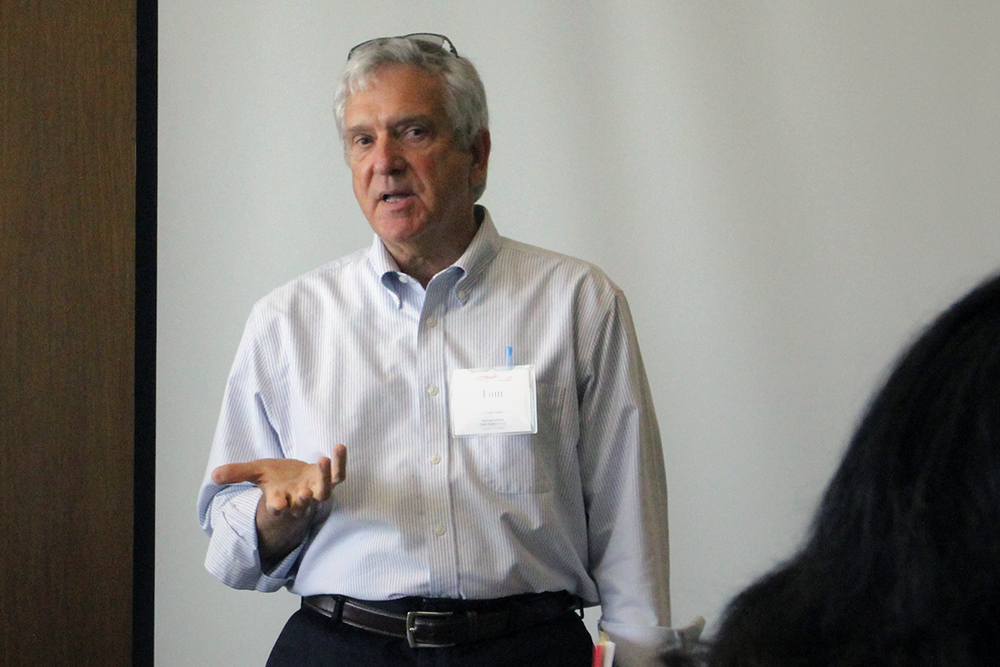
267;609;593;667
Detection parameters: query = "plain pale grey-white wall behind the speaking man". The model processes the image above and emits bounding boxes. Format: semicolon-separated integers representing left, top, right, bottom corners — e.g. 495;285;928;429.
156;0;1000;667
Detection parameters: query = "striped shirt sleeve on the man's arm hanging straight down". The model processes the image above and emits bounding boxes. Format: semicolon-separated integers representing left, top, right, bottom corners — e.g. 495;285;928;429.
580;288;677;667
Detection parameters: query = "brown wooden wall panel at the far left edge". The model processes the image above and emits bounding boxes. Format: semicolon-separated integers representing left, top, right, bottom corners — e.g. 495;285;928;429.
0;0;136;667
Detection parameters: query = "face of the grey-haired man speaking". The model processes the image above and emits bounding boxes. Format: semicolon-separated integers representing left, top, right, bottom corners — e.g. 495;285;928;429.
344;65;488;255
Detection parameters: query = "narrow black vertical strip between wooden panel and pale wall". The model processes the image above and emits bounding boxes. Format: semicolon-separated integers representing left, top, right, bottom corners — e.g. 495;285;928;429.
132;0;158;667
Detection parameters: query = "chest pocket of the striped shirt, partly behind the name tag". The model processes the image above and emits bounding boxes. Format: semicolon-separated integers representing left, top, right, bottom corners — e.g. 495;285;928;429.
458;382;568;493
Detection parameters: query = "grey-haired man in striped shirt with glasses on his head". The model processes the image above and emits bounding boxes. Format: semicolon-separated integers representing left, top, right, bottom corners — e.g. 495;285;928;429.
199;34;676;667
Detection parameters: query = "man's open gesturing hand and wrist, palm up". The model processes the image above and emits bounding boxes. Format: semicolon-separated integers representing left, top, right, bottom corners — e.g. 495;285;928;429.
212;445;347;572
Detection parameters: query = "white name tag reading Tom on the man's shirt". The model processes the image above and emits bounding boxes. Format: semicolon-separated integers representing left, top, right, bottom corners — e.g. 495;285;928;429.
448;366;538;438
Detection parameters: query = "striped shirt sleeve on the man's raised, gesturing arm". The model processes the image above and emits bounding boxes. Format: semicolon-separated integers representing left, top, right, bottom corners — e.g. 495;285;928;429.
198;308;302;592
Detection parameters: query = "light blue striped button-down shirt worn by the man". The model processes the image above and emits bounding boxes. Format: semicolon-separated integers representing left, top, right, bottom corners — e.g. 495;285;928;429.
198;208;670;664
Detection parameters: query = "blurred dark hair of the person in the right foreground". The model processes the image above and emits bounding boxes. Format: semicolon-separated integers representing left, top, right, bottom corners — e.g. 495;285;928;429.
711;275;1000;667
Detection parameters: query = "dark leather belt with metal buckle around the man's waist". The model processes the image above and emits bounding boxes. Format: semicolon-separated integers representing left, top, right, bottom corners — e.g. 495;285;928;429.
302;591;580;648
